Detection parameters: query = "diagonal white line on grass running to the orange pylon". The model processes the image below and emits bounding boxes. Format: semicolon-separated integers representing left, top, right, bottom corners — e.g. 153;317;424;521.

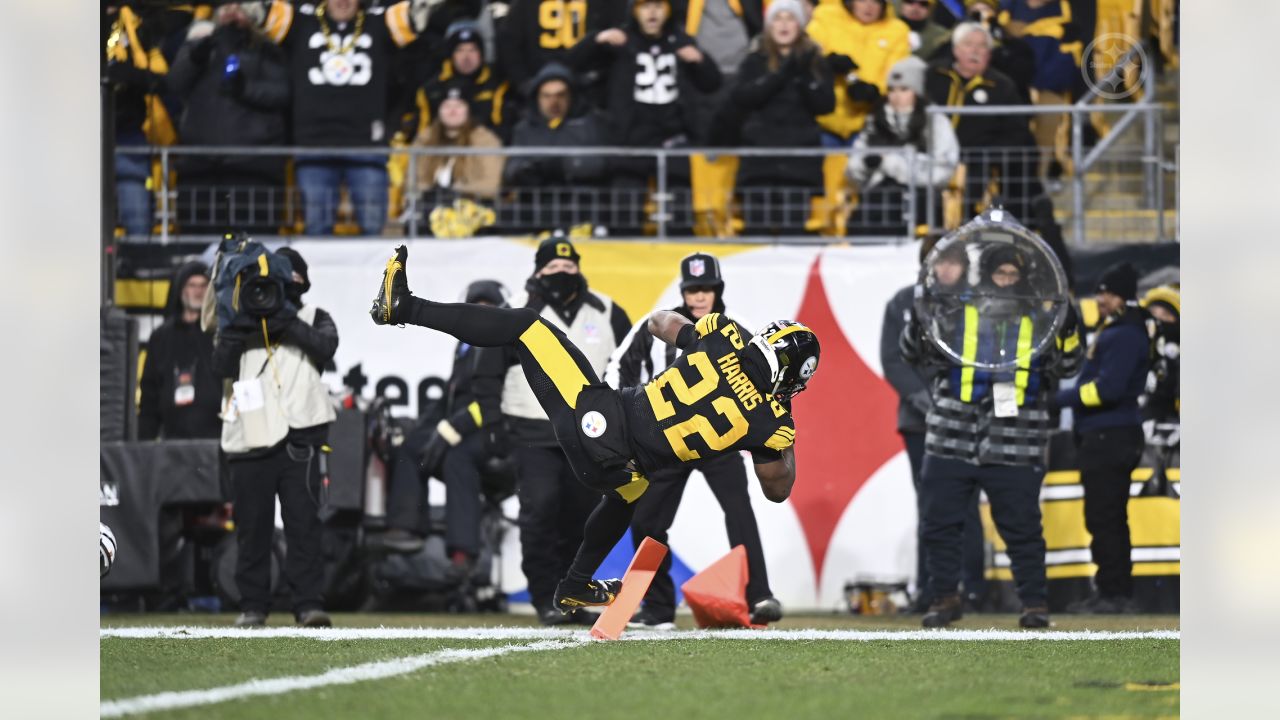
100;635;581;717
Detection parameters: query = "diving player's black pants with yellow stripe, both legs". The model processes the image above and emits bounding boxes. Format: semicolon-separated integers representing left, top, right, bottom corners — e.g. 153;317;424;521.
404;296;649;582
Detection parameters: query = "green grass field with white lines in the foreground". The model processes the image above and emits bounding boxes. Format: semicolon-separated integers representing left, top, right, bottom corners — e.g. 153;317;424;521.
101;615;1179;720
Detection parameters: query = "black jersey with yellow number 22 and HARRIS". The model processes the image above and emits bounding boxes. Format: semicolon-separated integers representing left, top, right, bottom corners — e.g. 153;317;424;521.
621;313;795;473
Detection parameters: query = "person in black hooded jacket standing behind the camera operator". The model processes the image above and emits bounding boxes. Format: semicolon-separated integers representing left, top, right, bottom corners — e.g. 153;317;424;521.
138;257;223;439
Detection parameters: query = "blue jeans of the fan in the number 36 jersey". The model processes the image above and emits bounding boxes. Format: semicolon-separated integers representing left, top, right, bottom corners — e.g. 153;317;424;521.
297;155;388;234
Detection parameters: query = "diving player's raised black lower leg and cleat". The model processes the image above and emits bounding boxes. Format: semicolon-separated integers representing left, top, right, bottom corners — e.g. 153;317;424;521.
369;245;538;347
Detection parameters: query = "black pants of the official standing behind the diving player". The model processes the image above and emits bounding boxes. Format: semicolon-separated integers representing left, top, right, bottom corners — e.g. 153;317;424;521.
631;452;773;619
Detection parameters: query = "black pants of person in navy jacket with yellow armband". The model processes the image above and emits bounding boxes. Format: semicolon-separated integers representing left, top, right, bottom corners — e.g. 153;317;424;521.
1075;425;1146;597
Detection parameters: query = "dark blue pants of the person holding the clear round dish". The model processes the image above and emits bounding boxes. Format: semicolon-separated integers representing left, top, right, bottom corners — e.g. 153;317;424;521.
920;452;1048;607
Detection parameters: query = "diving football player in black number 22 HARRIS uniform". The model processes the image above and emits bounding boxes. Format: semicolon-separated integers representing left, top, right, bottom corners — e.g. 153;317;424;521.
370;245;820;612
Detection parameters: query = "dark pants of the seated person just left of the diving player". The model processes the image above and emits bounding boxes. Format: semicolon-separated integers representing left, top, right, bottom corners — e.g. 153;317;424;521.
387;423;485;557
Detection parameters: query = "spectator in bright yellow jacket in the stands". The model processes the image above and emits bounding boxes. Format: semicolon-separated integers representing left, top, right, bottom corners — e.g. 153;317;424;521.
806;0;911;144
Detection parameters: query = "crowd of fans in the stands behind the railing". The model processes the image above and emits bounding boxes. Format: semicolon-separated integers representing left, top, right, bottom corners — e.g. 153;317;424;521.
104;0;1172;236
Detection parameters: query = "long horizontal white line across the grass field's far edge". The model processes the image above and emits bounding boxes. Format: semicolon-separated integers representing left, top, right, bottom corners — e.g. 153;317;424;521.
100;625;1181;642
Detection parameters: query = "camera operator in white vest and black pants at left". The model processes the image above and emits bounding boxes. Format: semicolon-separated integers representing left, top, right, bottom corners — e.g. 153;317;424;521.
214;247;338;628
